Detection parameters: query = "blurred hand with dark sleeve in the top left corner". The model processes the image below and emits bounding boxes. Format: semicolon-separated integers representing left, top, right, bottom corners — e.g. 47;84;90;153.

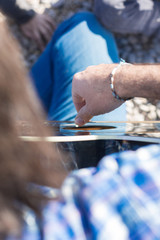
0;0;55;50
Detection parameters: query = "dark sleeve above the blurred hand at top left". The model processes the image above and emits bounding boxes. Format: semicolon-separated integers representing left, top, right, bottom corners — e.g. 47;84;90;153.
0;0;35;24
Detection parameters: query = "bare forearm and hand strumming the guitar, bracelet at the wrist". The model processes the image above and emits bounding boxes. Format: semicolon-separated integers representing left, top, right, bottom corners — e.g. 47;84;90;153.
72;64;160;126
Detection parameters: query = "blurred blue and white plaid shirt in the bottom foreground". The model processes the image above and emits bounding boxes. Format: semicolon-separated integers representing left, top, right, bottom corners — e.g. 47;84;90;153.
16;145;160;240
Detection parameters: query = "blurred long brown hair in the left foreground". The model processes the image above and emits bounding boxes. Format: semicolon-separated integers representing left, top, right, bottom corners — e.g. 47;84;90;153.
0;23;66;239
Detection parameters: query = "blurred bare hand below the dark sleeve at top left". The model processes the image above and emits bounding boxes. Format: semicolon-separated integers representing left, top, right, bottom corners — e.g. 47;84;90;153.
20;14;55;50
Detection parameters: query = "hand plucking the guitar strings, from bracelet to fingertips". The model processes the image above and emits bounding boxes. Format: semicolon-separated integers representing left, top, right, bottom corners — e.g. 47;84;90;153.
72;64;122;126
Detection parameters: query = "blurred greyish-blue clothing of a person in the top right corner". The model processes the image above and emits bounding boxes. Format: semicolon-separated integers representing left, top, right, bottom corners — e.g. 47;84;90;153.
94;0;160;36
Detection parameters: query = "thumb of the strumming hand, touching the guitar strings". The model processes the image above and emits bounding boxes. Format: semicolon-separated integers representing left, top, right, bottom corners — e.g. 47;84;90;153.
75;105;93;126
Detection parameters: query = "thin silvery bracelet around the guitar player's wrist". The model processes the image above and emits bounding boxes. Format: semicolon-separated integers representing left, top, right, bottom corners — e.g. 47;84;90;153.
110;58;132;102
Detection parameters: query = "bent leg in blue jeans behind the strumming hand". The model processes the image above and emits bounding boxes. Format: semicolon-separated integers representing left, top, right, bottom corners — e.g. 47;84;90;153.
31;12;126;121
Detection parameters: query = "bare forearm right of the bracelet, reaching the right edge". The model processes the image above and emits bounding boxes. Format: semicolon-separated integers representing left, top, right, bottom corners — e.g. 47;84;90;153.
114;64;160;99
